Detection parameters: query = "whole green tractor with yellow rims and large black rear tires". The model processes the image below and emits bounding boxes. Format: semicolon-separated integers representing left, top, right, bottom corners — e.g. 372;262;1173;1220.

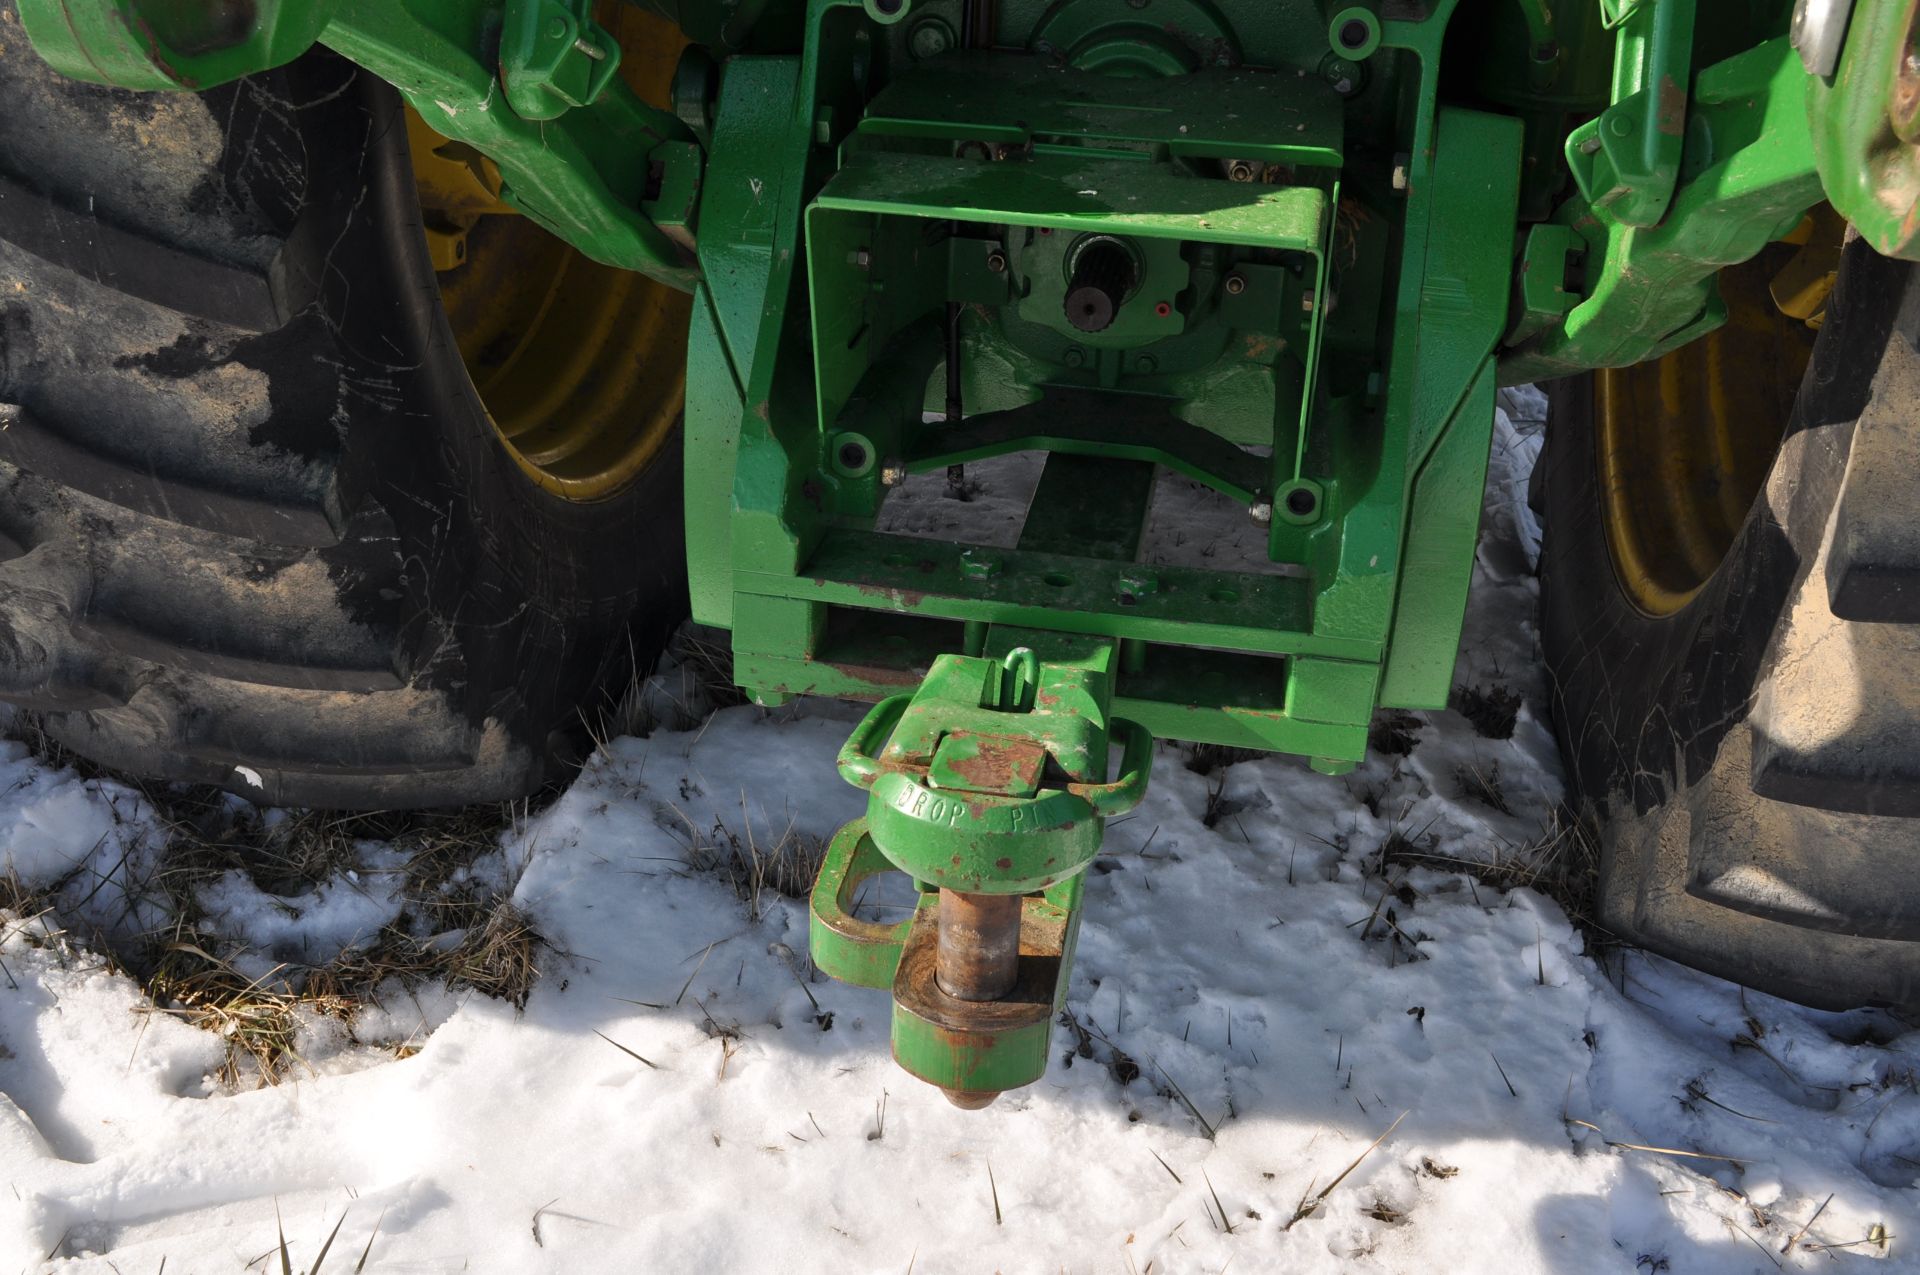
0;0;1920;1106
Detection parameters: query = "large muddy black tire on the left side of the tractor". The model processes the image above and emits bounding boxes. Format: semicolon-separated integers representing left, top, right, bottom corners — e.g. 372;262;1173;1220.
0;22;685;808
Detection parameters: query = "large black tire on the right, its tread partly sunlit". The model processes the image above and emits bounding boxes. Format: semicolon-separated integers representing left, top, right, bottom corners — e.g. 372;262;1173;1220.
1542;240;1920;1008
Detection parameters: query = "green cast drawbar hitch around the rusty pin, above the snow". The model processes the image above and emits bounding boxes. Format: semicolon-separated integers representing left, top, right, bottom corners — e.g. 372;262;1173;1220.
808;634;1154;1095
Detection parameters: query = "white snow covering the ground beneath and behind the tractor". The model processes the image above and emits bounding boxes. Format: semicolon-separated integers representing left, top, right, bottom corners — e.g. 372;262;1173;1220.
0;397;1920;1275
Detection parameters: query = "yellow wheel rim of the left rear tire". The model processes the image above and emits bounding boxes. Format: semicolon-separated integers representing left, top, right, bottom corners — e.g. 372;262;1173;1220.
407;4;691;501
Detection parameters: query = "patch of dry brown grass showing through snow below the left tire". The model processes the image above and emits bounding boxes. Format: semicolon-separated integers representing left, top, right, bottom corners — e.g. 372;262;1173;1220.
0;714;545;1087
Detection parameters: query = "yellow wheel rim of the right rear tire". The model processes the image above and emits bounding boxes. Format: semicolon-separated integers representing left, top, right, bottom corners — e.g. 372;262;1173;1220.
1594;217;1839;616
